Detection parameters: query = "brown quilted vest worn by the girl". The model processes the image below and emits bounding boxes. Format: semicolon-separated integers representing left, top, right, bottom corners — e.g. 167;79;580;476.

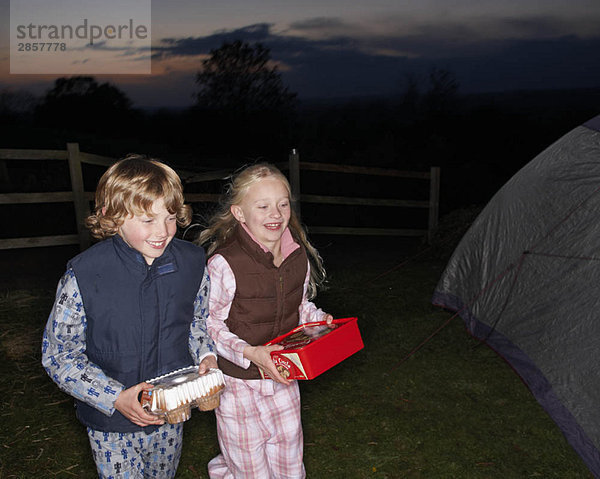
215;226;308;379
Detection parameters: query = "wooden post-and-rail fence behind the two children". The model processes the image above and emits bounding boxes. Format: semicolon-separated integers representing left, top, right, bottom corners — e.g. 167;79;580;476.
0;143;440;250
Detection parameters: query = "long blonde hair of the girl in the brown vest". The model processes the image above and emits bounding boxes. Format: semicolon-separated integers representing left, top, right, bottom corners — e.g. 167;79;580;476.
196;163;326;299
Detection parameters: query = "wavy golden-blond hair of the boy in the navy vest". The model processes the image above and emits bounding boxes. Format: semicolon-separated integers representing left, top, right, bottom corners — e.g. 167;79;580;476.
85;155;192;239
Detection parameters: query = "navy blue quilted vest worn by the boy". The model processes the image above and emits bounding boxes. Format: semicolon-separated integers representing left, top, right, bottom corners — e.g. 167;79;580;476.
69;235;205;432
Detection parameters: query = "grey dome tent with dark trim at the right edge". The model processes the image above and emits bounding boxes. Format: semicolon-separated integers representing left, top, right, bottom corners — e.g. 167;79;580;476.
433;115;600;477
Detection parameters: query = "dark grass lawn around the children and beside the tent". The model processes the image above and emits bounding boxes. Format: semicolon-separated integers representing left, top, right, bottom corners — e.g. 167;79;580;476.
0;239;591;479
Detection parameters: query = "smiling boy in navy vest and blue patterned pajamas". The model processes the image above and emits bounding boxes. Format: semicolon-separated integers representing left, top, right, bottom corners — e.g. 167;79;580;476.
42;155;217;478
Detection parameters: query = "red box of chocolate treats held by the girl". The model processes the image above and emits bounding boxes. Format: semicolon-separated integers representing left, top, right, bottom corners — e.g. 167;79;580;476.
260;318;364;379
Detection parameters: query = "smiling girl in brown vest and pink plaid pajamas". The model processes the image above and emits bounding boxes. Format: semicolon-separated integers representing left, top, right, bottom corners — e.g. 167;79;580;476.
199;164;333;478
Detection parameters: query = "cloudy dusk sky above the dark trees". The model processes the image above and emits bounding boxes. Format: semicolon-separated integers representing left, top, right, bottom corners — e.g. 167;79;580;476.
0;0;600;107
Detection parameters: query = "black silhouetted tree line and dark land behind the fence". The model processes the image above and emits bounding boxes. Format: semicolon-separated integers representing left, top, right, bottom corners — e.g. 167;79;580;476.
0;40;598;213
